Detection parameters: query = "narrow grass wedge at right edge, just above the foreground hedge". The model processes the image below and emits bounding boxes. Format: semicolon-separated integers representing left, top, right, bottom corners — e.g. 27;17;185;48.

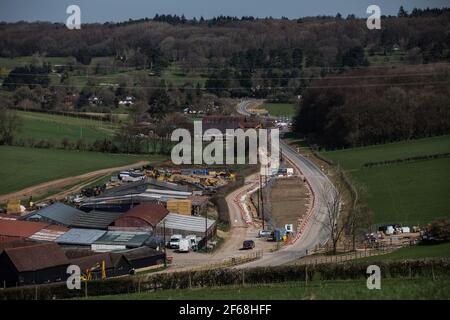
358;243;450;262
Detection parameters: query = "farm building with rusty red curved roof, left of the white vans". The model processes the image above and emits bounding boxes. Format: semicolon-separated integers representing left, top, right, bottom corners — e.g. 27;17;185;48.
114;202;169;231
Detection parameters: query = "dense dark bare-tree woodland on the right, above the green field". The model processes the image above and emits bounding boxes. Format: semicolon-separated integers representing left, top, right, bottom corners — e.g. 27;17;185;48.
294;63;450;148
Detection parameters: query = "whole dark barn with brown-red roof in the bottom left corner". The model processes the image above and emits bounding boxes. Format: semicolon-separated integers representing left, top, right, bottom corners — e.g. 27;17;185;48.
0;243;69;286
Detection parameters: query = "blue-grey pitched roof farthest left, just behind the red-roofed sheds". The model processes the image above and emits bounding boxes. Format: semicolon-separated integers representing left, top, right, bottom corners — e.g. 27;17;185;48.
26;202;84;226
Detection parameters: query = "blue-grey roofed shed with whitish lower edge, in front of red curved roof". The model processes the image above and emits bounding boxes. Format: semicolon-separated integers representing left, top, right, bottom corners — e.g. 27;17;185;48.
91;231;150;252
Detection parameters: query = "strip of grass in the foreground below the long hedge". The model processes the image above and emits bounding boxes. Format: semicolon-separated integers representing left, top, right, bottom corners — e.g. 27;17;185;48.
90;278;450;300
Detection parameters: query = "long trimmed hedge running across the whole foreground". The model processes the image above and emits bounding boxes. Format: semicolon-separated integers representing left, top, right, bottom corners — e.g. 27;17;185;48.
0;259;450;300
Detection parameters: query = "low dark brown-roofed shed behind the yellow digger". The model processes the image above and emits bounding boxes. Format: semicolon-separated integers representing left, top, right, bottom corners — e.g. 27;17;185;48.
69;252;131;280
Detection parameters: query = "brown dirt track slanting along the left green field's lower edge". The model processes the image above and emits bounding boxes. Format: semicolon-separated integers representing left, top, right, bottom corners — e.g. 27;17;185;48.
0;161;149;202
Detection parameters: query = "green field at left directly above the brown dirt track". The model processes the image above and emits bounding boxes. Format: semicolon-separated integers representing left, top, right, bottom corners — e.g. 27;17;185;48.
0;146;165;194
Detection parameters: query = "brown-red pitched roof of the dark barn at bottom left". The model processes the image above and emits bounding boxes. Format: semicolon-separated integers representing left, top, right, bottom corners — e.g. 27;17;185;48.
3;243;69;272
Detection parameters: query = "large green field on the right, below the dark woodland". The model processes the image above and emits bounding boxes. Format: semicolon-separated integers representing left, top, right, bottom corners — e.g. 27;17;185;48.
323;136;450;226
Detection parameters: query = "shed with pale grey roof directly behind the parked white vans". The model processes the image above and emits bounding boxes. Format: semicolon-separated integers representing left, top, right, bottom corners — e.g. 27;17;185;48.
156;213;217;240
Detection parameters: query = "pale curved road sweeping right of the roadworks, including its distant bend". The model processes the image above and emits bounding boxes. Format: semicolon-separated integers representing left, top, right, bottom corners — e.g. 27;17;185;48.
237;100;335;268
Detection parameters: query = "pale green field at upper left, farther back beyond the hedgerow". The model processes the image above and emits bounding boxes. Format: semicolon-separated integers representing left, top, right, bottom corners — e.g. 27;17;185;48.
17;111;117;144
